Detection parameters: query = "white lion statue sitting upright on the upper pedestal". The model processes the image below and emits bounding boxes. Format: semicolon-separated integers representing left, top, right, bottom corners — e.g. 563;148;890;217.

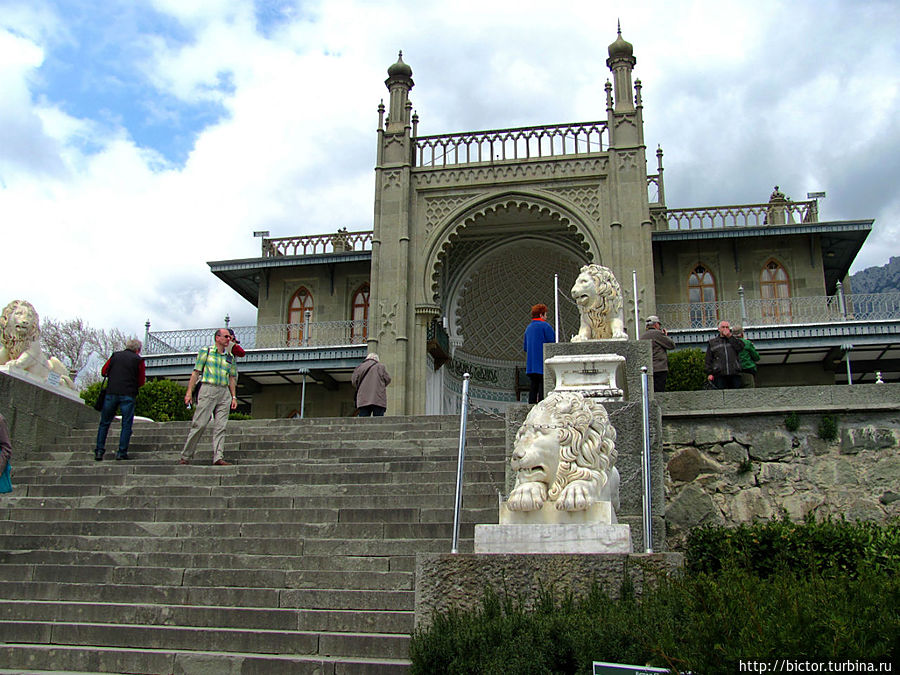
571;265;628;342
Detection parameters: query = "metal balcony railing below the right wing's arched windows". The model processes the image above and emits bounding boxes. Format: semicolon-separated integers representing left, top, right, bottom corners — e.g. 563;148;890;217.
656;293;900;330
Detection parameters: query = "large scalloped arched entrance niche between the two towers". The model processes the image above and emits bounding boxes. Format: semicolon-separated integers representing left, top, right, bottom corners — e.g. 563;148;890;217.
429;202;593;413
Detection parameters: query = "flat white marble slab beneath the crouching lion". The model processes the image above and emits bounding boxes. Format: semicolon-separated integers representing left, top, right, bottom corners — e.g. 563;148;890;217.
475;524;633;553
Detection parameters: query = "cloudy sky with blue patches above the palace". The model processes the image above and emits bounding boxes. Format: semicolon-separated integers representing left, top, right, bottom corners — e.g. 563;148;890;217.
0;0;900;336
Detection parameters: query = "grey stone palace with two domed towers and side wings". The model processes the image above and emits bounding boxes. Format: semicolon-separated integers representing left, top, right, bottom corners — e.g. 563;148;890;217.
144;33;900;417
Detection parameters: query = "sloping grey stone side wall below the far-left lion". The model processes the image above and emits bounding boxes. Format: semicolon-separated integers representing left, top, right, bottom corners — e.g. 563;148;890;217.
0;372;100;463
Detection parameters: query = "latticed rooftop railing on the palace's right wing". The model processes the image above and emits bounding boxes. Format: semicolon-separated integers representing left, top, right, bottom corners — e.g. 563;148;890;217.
666;200;819;230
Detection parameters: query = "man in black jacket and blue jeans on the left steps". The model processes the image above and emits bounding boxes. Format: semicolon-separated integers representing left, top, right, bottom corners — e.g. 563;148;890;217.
94;340;146;462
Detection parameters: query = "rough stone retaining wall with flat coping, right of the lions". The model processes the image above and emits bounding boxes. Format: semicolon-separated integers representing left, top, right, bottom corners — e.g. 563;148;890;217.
658;385;900;550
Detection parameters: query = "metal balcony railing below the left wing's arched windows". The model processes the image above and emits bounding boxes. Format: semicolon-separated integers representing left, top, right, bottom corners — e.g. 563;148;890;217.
143;321;366;354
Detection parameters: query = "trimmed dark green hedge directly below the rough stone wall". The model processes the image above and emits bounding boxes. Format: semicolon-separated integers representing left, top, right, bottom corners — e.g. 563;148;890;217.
685;516;900;578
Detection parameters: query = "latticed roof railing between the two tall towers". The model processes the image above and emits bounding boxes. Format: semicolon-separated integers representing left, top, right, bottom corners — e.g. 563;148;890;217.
415;122;609;167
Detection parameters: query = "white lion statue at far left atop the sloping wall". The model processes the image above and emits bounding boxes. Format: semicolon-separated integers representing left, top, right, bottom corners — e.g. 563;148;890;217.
0;300;75;390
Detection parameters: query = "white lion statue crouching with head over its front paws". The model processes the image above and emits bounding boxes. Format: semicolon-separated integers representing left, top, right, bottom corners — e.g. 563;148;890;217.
506;391;619;511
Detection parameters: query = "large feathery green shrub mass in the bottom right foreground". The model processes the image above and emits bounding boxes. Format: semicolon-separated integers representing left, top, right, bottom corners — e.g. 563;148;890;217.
410;567;900;675
